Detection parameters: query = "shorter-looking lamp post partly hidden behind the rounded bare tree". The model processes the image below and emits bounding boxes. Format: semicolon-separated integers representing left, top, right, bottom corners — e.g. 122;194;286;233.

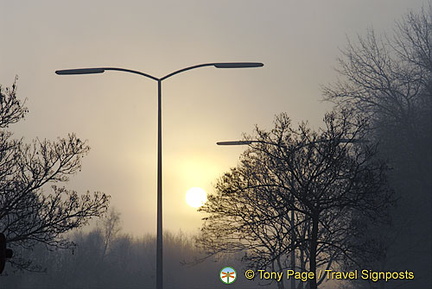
216;138;365;289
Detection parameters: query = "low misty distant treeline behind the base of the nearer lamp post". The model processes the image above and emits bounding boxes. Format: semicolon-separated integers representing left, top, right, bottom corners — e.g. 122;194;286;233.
0;212;256;289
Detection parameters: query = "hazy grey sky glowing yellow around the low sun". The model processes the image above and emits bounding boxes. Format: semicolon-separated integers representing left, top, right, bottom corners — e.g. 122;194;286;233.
0;0;427;235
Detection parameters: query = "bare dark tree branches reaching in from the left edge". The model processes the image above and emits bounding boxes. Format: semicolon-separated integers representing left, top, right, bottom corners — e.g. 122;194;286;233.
0;80;109;269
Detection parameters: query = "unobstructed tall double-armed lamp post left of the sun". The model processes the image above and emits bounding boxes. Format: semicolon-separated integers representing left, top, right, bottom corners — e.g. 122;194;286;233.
55;62;264;289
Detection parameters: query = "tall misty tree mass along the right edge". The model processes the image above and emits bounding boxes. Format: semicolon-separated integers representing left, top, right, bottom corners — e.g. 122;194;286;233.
324;4;432;288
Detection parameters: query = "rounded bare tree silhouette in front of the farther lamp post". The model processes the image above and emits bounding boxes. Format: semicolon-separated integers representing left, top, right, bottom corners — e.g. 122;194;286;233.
198;111;392;289
